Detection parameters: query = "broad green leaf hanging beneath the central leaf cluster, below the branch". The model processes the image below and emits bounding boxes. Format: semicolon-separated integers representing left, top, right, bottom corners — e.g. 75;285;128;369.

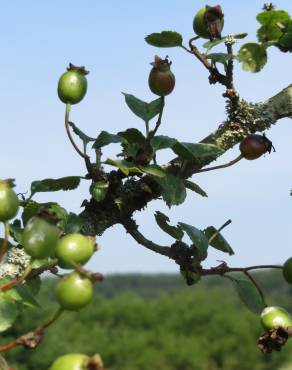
153;174;187;207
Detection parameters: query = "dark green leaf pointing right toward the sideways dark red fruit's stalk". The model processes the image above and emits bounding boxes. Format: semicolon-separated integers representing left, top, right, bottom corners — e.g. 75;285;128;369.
172;142;224;162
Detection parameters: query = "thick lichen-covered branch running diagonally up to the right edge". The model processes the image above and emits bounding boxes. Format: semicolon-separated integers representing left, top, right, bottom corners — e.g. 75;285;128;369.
80;85;292;235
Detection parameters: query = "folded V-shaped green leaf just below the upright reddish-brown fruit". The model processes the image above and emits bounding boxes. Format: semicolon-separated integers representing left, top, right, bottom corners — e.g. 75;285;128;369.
122;93;161;122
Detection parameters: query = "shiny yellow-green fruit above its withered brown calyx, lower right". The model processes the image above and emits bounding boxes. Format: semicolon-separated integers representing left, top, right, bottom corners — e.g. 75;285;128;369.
261;307;292;330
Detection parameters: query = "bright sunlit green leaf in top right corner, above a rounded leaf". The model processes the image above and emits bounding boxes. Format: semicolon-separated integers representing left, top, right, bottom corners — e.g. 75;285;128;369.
257;10;290;42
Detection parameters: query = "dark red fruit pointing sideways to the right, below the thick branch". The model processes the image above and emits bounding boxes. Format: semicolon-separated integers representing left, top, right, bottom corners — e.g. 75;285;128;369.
239;134;275;160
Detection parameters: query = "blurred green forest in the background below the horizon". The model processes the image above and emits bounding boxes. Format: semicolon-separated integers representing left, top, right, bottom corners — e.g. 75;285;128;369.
1;271;292;370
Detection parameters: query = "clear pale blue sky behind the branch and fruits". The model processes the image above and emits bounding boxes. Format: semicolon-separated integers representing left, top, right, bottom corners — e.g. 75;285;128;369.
0;0;292;273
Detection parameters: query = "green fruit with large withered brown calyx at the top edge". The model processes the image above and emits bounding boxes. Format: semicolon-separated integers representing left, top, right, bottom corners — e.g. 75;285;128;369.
193;5;224;40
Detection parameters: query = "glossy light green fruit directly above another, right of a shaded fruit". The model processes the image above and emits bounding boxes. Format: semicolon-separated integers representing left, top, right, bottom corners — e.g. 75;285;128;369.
56;234;94;269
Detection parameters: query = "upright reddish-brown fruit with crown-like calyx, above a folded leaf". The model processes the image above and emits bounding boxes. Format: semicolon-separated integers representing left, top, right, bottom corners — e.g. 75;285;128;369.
148;55;175;96
